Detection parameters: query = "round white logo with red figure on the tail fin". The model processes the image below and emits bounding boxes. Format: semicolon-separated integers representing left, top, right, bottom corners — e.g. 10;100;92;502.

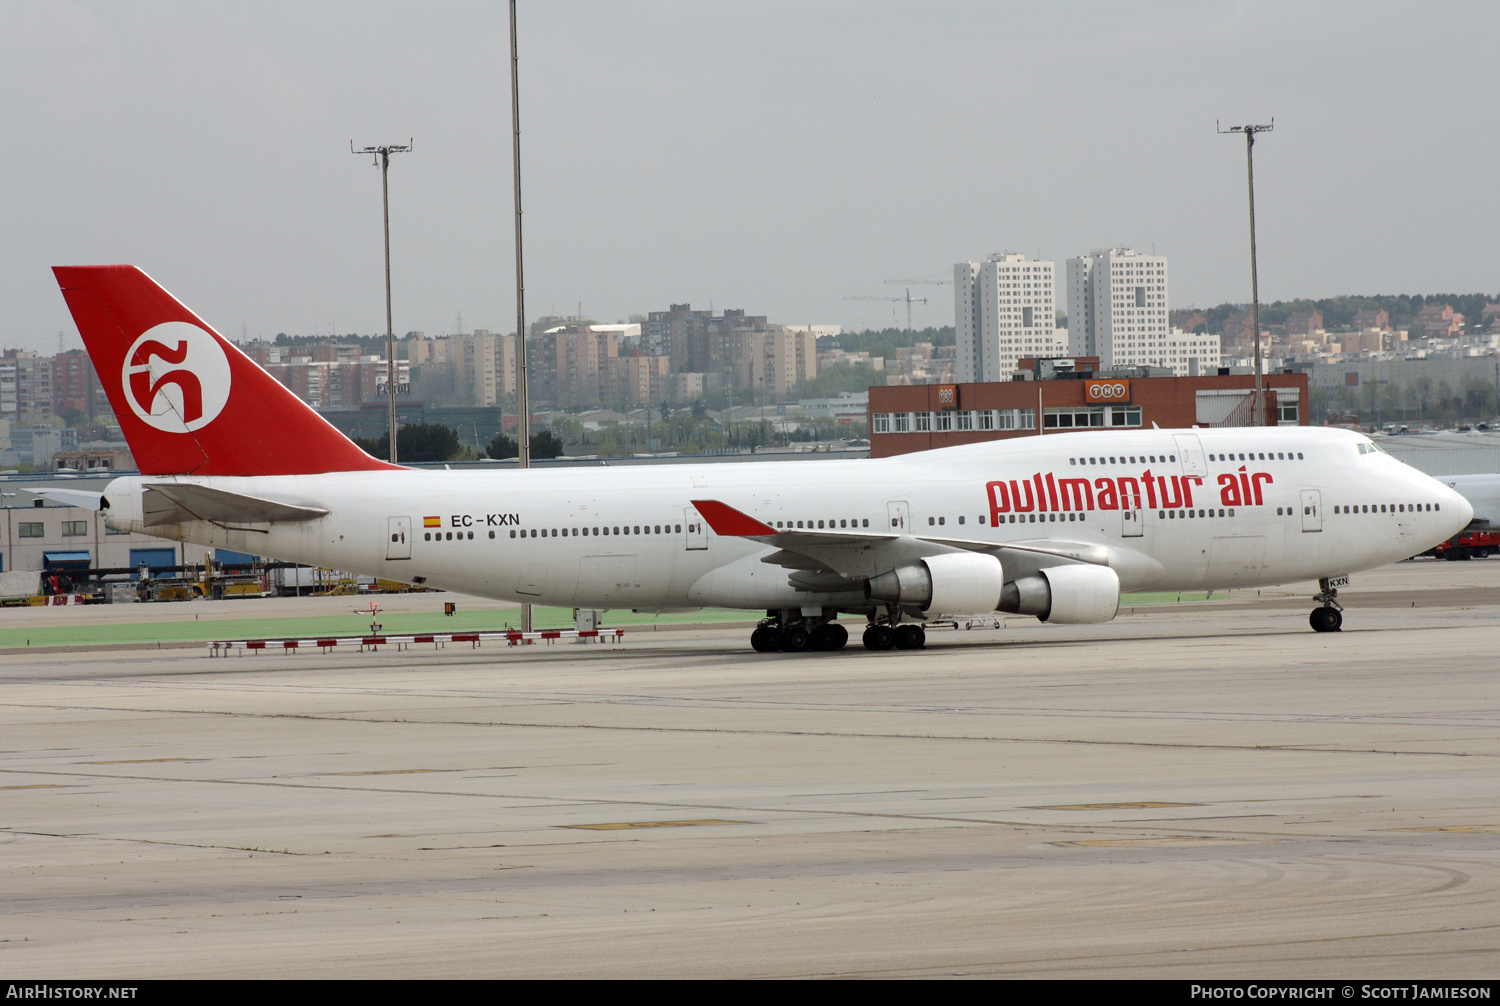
122;321;230;433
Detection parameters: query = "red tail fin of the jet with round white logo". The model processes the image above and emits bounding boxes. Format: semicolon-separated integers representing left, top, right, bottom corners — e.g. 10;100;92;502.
53;265;392;475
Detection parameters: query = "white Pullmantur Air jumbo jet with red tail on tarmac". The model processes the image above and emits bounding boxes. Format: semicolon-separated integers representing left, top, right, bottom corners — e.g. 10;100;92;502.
46;265;1473;652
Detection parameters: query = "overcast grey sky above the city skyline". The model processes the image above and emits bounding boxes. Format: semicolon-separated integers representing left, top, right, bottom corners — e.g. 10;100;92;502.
0;0;1500;351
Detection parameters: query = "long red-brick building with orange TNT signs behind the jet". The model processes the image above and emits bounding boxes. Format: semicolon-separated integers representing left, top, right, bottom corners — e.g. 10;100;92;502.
870;358;1308;457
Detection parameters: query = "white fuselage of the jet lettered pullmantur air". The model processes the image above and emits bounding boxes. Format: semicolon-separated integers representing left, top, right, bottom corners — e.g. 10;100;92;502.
105;427;1472;610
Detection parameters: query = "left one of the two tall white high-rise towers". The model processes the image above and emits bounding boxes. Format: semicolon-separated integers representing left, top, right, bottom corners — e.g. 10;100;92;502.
953;252;1067;382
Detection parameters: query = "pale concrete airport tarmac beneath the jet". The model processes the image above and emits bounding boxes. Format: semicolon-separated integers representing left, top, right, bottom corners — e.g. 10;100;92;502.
0;559;1500;979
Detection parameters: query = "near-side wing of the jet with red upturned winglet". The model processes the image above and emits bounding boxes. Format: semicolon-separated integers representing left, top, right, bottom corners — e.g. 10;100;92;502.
693;499;1110;589
